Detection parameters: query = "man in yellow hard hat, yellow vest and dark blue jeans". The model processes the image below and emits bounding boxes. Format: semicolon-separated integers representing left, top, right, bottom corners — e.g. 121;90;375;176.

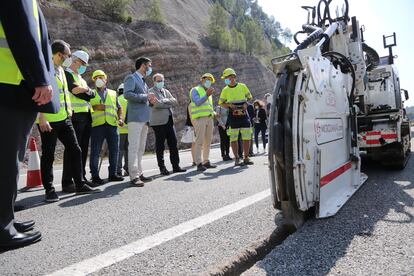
89;70;124;185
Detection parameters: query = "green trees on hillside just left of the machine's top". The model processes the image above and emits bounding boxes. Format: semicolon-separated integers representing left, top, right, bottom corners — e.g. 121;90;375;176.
208;0;292;60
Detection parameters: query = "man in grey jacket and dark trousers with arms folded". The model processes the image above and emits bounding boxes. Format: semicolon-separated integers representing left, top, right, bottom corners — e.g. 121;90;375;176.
148;74;186;175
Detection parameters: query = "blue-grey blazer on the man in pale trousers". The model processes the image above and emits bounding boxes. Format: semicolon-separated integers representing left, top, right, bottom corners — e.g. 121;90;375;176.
124;72;151;123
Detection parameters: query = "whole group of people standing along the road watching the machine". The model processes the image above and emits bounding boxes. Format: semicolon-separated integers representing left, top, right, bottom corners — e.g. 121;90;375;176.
0;0;272;250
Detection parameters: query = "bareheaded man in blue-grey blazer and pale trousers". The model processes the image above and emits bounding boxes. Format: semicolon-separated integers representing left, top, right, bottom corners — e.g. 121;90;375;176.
124;57;155;187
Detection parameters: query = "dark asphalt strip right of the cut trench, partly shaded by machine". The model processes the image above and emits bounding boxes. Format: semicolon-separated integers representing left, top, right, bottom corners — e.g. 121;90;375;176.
243;138;414;276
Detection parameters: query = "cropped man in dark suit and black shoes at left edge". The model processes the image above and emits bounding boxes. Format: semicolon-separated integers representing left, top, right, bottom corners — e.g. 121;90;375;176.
0;0;59;251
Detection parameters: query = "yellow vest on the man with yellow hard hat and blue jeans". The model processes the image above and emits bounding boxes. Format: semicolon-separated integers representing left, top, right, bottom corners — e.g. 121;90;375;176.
91;89;118;127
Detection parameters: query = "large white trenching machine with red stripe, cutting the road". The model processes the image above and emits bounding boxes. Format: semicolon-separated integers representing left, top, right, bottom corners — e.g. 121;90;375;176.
269;0;409;227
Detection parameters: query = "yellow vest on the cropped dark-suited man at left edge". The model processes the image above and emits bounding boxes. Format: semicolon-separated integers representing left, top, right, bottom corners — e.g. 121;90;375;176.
0;0;41;85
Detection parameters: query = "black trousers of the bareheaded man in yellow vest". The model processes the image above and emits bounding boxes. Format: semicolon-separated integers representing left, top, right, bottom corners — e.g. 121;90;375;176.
39;119;83;192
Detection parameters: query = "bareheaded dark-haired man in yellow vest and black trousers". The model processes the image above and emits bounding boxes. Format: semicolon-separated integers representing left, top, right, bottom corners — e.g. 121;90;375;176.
38;40;95;202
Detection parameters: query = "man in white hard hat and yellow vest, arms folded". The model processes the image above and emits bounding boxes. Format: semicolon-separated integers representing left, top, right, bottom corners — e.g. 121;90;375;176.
62;50;95;186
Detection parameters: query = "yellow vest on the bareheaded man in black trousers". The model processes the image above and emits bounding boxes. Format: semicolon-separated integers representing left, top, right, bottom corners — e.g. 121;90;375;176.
43;67;72;123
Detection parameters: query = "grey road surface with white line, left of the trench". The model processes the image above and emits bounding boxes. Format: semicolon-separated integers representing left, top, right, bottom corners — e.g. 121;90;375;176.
0;148;276;275
